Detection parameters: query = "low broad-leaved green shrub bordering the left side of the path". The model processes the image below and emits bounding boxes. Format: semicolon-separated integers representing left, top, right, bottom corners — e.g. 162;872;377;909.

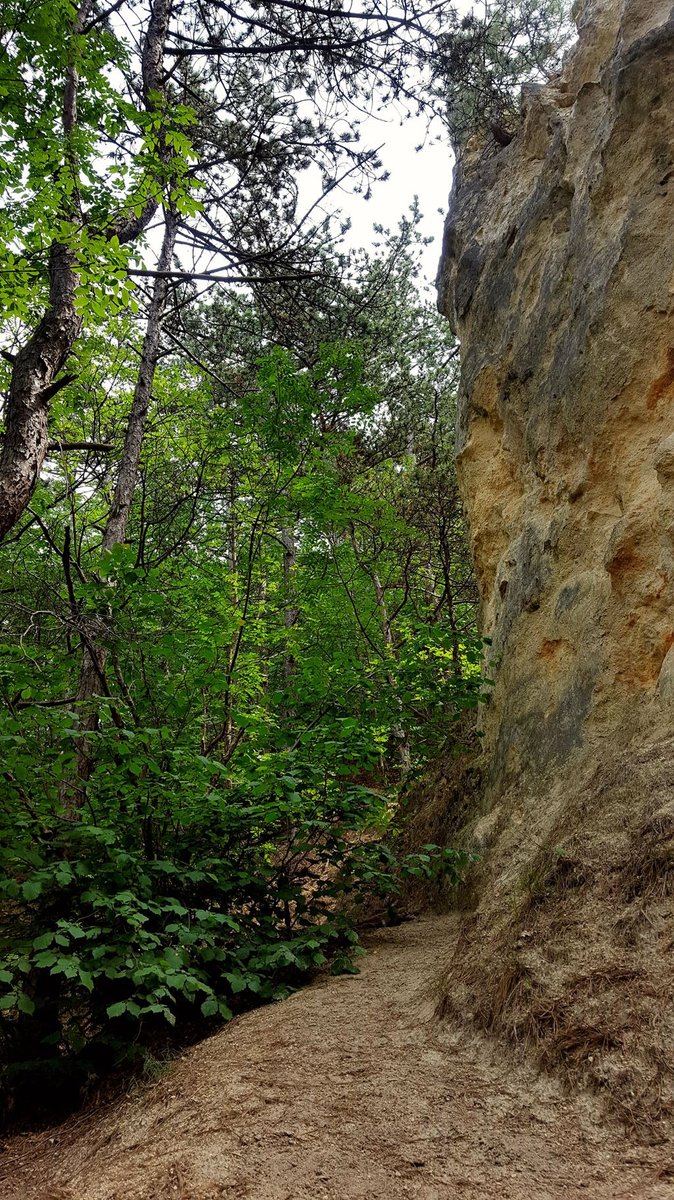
0;710;472;1118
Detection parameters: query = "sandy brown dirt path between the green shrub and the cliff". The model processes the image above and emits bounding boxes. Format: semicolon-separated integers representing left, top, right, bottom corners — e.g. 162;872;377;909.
0;917;674;1200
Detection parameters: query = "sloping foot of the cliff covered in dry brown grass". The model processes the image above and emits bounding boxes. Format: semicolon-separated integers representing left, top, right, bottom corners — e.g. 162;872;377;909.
439;739;674;1142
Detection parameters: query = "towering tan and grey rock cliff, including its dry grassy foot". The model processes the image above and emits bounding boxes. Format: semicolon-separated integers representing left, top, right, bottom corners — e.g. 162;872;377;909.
440;0;674;1124
